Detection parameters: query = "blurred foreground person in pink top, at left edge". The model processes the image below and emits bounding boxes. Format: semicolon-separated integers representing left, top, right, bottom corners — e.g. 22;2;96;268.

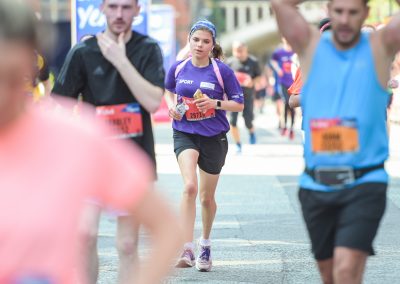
0;0;181;284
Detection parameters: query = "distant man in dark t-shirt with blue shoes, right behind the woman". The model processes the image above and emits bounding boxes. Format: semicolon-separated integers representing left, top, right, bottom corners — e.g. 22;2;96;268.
226;41;261;153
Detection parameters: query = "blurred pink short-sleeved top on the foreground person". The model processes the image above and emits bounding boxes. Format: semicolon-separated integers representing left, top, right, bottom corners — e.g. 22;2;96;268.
0;101;152;284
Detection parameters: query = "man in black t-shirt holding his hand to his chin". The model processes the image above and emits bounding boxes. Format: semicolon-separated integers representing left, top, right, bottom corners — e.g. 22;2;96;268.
53;0;165;283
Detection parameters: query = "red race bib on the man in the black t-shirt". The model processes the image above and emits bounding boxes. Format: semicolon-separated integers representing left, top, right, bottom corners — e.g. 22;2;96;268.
96;103;143;138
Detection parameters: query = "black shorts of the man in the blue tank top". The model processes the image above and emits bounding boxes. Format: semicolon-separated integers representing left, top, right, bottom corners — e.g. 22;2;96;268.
299;183;387;260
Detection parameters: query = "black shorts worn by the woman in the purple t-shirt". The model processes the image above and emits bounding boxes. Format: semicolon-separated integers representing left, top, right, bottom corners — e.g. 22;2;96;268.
173;129;228;175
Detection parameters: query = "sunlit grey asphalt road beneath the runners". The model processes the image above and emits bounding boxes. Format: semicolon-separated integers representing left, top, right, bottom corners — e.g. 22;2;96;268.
99;105;400;284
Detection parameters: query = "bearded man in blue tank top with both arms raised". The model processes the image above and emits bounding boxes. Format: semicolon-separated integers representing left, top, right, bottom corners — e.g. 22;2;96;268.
272;0;400;283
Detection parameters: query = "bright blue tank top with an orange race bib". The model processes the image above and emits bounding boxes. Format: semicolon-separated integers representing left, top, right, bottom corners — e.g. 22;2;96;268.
300;32;389;191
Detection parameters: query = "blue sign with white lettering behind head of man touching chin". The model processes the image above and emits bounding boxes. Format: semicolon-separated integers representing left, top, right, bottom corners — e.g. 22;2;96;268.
71;0;150;44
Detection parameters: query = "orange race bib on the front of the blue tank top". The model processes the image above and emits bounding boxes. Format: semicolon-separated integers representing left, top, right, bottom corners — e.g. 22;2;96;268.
311;119;359;154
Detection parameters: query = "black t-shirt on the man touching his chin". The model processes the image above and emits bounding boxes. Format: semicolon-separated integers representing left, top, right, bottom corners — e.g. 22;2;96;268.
53;31;165;161
